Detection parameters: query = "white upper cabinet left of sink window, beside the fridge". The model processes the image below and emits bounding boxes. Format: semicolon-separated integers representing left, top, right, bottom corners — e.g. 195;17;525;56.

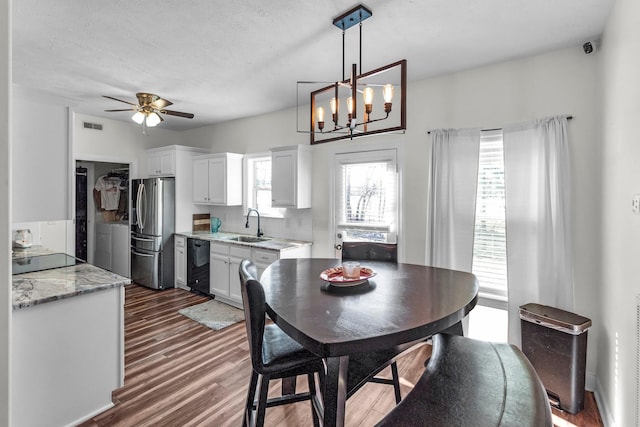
193;153;243;206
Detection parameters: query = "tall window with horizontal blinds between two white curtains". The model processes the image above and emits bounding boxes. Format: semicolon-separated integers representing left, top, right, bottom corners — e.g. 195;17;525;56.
472;131;507;301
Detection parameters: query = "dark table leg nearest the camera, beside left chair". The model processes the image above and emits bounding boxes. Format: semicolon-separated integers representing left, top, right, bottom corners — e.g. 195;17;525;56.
322;356;349;427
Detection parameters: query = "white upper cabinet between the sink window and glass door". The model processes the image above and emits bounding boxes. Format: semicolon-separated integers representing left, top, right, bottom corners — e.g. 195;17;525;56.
271;145;312;209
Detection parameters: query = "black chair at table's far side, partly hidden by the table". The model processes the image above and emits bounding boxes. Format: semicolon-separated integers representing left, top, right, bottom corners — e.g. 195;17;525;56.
342;242;402;403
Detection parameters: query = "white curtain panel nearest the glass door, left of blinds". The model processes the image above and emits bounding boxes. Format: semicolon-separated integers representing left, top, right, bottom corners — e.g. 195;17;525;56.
425;129;480;272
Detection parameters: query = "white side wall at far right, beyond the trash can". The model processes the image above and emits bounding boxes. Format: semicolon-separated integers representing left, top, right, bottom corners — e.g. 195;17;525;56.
596;0;640;426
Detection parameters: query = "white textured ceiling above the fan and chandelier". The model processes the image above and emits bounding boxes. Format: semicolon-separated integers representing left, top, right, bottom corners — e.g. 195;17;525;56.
12;0;614;130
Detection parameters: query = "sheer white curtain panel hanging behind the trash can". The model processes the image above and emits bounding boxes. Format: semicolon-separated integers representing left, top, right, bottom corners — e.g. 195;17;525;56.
503;117;573;345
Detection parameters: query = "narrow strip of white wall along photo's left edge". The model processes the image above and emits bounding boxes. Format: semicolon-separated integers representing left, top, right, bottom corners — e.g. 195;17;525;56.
0;1;12;426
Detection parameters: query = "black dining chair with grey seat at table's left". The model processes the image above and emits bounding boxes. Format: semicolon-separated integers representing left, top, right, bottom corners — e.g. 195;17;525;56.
239;259;324;427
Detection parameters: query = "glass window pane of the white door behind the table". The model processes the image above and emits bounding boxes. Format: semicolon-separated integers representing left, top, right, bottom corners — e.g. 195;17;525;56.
335;150;398;243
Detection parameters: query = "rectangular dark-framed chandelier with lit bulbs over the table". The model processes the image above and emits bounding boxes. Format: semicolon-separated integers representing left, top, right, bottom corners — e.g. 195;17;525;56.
298;5;407;144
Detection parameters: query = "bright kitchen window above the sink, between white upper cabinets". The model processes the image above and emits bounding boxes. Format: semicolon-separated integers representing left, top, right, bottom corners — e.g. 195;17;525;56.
245;154;284;218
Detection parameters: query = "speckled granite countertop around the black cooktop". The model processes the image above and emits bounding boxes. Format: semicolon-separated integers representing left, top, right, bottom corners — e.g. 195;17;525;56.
12;246;131;310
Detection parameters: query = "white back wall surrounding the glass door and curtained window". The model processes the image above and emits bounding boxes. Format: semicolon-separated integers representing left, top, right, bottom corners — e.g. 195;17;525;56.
184;46;600;386
